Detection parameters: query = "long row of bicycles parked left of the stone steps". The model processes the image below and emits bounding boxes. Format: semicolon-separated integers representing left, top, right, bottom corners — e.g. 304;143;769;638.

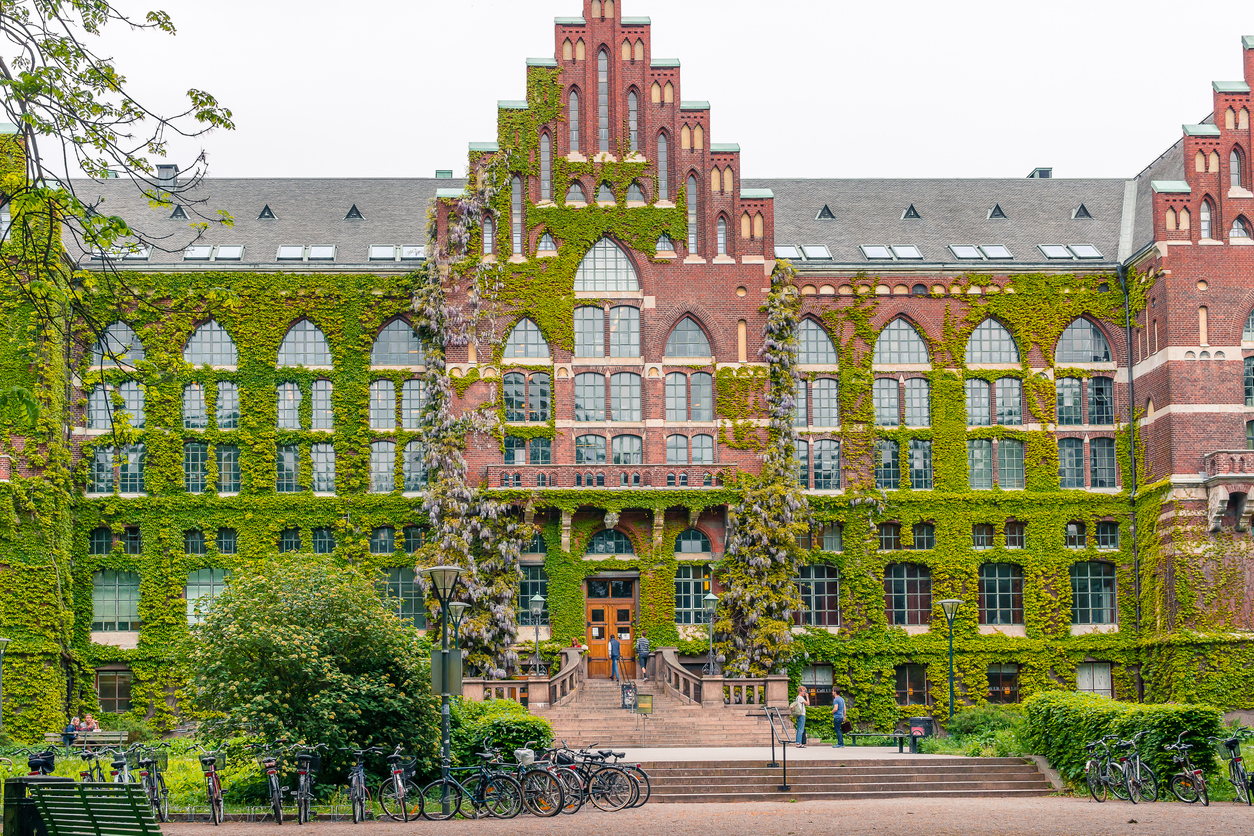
7;738;652;825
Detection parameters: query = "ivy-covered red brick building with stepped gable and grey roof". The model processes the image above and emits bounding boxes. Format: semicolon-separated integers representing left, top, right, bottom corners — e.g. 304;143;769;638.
0;0;1254;737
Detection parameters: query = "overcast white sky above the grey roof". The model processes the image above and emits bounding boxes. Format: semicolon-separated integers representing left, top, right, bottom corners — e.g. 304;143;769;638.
90;0;1254;178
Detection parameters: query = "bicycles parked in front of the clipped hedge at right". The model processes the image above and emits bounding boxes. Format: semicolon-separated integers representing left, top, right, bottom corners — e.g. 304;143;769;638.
1085;727;1254;806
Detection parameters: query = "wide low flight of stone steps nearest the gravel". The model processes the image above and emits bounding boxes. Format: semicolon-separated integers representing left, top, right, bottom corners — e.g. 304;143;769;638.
642;752;1053;803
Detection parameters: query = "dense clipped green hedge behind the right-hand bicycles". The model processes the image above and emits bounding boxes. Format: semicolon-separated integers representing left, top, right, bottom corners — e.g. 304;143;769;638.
1023;691;1223;786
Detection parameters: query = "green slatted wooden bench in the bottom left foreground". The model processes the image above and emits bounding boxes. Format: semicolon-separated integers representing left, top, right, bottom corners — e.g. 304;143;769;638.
28;782;161;836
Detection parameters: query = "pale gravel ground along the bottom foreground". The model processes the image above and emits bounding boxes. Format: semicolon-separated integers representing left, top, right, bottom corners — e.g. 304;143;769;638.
162;797;1254;836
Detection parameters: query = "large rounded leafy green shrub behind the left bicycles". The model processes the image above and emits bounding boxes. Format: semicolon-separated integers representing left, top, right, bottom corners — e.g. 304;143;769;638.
191;558;439;772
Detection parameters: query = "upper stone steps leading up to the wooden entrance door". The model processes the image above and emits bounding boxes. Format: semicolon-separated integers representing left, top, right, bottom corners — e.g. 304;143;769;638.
532;679;771;748
